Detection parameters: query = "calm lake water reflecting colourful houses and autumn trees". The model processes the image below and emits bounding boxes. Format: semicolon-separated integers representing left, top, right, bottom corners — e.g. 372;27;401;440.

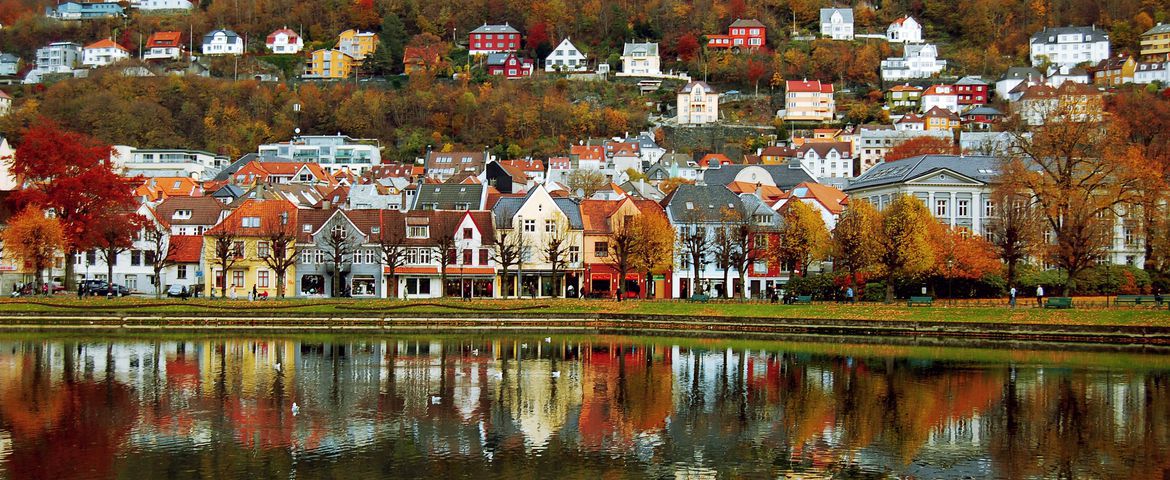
0;336;1170;480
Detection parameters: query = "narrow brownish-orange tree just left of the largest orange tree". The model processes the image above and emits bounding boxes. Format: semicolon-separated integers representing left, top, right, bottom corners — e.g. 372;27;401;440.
986;160;1044;287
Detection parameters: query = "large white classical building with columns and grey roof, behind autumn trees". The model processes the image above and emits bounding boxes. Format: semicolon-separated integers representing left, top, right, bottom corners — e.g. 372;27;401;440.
845;155;1144;266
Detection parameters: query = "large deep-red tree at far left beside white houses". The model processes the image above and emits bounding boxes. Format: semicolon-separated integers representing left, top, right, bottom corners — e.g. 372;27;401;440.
11;118;142;288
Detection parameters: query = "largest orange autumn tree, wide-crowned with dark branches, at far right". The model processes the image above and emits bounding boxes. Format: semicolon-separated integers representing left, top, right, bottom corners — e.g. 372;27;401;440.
1012;95;1149;293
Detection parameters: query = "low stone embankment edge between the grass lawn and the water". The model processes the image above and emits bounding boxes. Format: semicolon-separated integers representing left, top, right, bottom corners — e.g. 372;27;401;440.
0;311;1170;347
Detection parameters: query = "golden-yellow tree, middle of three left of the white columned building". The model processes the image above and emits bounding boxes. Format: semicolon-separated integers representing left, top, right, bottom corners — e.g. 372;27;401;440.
832;200;881;289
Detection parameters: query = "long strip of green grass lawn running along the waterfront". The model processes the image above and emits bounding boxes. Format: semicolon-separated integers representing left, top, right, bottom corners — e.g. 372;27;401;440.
0;296;1170;327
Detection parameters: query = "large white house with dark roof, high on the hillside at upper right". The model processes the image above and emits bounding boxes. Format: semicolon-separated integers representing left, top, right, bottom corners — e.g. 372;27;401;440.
1028;26;1109;68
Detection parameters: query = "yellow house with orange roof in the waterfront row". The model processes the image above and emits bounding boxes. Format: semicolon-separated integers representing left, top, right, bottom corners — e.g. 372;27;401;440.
202;200;297;299
